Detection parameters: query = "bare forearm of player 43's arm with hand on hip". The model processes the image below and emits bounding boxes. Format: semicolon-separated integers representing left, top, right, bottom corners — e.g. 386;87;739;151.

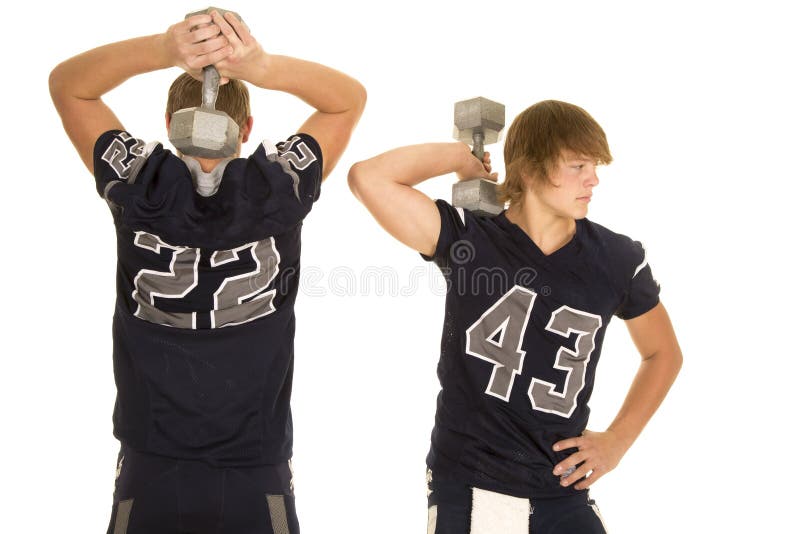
608;346;683;447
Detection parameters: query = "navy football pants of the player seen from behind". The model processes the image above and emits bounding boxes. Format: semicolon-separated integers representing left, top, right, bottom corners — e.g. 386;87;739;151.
108;446;300;534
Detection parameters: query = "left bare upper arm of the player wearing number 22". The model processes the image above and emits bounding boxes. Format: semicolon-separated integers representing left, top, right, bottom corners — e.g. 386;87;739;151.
50;68;124;173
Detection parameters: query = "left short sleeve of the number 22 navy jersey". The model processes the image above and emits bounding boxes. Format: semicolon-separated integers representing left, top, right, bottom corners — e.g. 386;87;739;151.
94;130;159;199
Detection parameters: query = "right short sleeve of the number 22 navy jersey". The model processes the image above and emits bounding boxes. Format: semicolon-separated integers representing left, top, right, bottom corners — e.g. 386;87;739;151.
249;133;322;211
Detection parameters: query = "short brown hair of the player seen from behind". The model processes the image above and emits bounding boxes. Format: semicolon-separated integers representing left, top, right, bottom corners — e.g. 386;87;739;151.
167;72;250;128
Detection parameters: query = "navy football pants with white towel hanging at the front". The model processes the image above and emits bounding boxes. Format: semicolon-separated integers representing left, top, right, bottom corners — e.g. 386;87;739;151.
428;481;606;534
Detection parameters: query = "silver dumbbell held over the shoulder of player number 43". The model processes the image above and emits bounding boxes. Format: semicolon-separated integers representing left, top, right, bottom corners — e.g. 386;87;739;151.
453;97;506;216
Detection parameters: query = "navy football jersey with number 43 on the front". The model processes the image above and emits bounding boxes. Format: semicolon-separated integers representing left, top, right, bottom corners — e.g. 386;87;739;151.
426;200;659;498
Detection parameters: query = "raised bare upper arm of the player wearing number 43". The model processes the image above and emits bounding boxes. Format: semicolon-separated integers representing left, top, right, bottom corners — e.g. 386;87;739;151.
348;160;442;256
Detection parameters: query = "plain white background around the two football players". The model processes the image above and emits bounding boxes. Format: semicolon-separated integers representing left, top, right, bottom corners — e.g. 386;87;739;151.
0;0;800;534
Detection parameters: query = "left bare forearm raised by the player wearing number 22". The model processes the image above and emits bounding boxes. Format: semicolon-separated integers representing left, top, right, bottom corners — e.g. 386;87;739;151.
50;34;172;100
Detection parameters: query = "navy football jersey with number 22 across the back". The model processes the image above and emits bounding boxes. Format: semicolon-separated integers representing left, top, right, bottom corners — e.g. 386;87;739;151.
94;131;322;466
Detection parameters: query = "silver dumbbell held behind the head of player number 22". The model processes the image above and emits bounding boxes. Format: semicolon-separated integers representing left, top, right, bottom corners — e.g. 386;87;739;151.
169;7;242;159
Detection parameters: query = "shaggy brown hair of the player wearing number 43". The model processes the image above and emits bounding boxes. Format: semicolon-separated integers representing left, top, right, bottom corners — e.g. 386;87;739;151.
498;100;612;204
